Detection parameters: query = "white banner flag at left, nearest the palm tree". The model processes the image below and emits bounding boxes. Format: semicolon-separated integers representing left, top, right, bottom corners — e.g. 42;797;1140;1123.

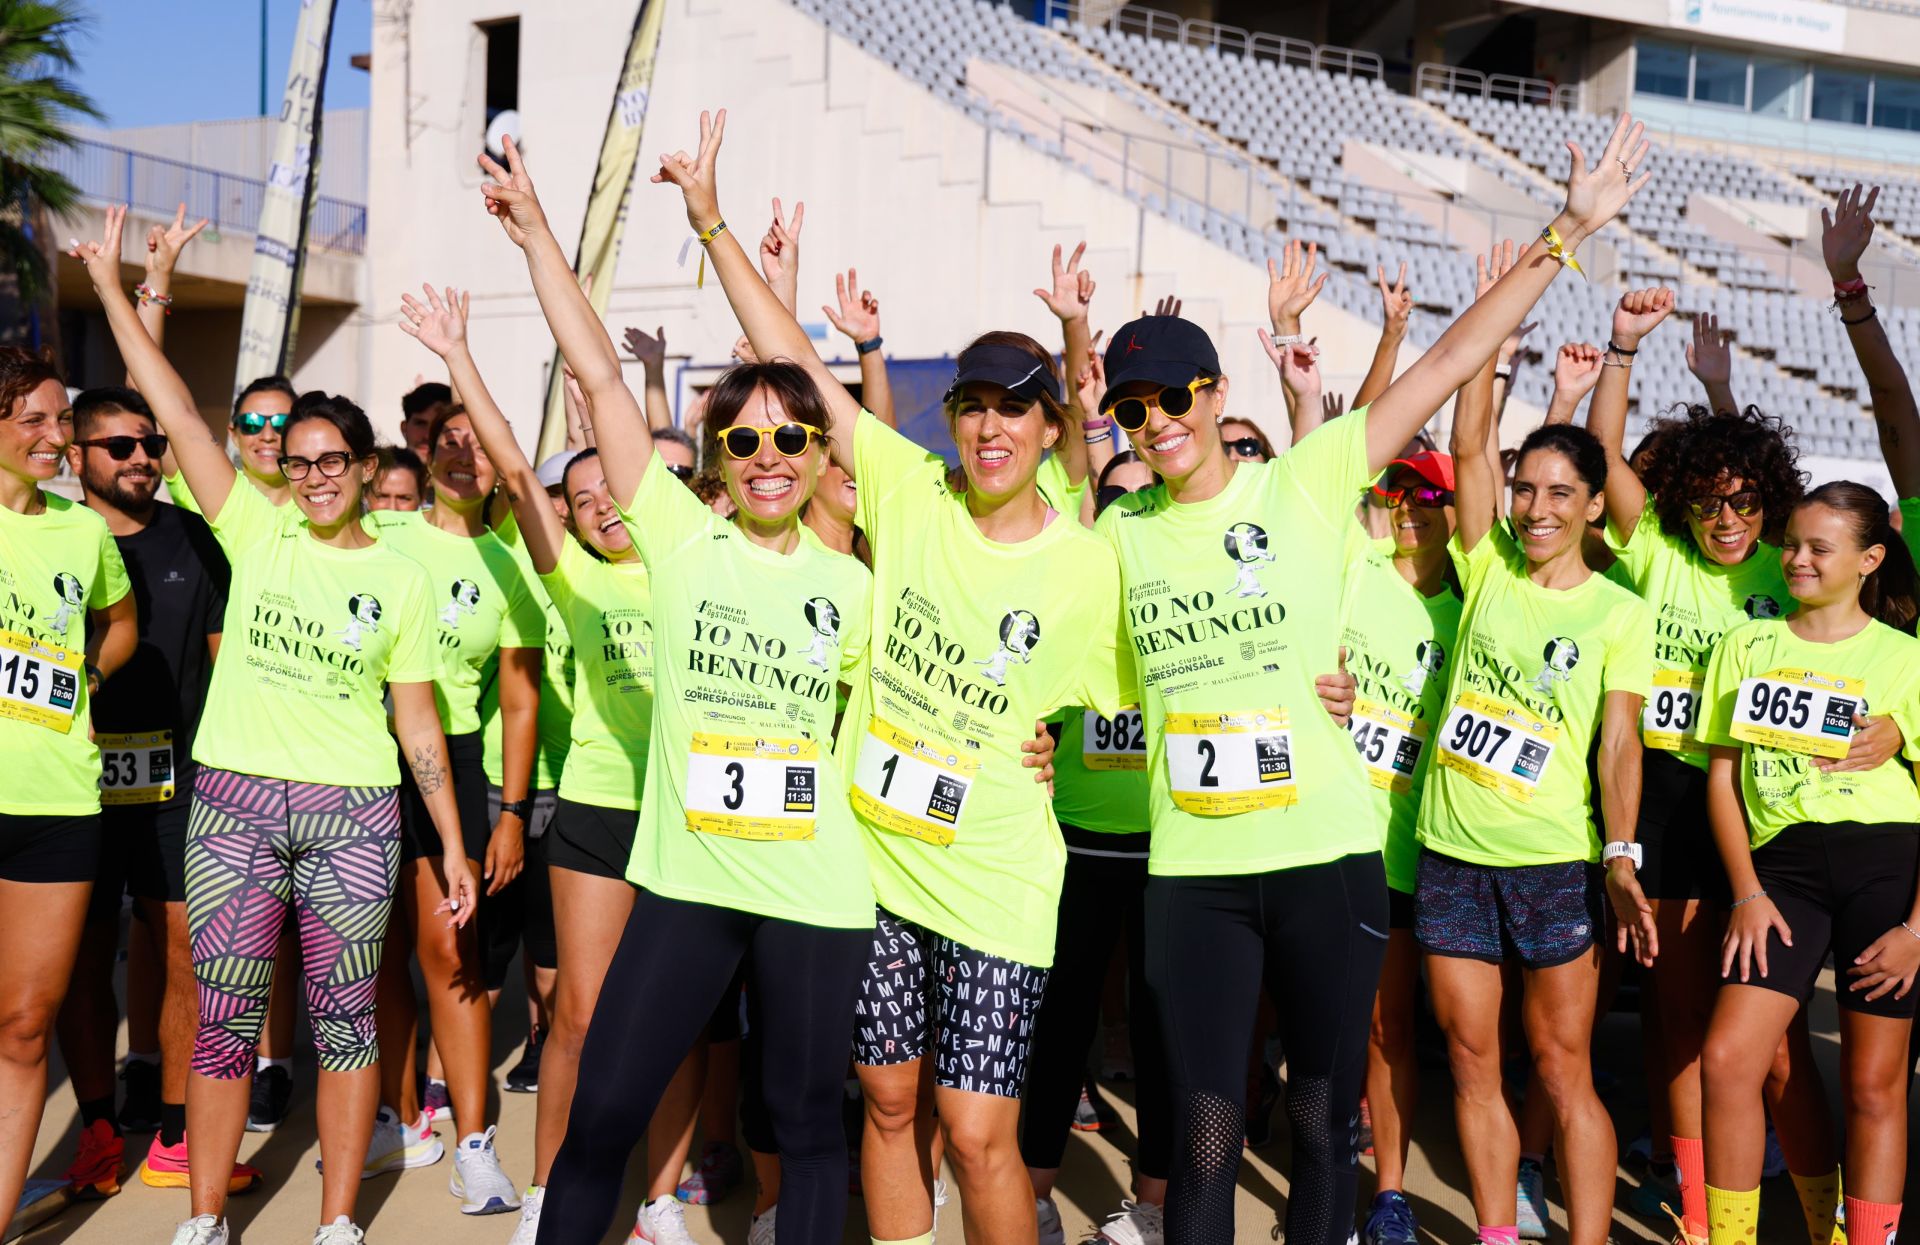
234;0;336;394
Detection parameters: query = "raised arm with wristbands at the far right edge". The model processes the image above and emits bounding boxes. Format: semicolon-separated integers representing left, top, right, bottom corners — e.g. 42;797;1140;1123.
1820;186;1920;498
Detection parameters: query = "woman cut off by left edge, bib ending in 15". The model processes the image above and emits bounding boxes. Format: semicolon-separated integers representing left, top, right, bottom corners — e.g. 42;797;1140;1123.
0;346;138;1229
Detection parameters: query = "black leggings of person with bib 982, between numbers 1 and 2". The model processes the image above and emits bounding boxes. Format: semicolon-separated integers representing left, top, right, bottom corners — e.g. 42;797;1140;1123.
1020;826;1173;1180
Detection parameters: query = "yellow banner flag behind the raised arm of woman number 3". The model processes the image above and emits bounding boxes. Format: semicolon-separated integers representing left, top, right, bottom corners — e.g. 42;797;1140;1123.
534;0;666;461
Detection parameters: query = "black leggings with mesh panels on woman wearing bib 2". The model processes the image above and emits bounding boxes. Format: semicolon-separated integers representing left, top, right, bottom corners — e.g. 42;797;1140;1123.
1146;853;1388;1245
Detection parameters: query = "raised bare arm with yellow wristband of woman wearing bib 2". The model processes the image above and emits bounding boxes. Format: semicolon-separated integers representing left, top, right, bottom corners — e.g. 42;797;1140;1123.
1367;113;1647;471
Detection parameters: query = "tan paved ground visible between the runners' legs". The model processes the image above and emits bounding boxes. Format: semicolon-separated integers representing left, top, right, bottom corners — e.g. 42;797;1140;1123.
11;945;1889;1245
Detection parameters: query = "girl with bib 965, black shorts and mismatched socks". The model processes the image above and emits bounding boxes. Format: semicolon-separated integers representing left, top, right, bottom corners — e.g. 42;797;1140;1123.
1688;480;1920;1245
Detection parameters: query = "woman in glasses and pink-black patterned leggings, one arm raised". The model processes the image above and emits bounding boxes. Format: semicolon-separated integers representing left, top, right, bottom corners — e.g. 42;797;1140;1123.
77;208;474;1245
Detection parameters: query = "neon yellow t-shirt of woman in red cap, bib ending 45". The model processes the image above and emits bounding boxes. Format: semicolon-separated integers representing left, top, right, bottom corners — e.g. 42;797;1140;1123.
1342;525;1461;895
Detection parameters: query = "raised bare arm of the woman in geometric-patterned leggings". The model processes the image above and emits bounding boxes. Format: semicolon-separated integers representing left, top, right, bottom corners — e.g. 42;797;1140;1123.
71;208;234;523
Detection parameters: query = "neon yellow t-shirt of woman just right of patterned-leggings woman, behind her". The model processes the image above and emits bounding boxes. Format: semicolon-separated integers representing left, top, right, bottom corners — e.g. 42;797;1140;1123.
363;511;547;736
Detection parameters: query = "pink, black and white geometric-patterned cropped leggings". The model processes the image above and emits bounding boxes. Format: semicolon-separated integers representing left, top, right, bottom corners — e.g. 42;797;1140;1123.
186;767;399;1080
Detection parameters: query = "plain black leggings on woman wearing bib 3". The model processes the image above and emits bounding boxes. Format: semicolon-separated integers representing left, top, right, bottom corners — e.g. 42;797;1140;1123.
540;891;874;1245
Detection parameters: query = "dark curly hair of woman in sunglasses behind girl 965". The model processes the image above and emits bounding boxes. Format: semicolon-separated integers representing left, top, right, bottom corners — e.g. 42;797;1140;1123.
1653;405;1807;544
